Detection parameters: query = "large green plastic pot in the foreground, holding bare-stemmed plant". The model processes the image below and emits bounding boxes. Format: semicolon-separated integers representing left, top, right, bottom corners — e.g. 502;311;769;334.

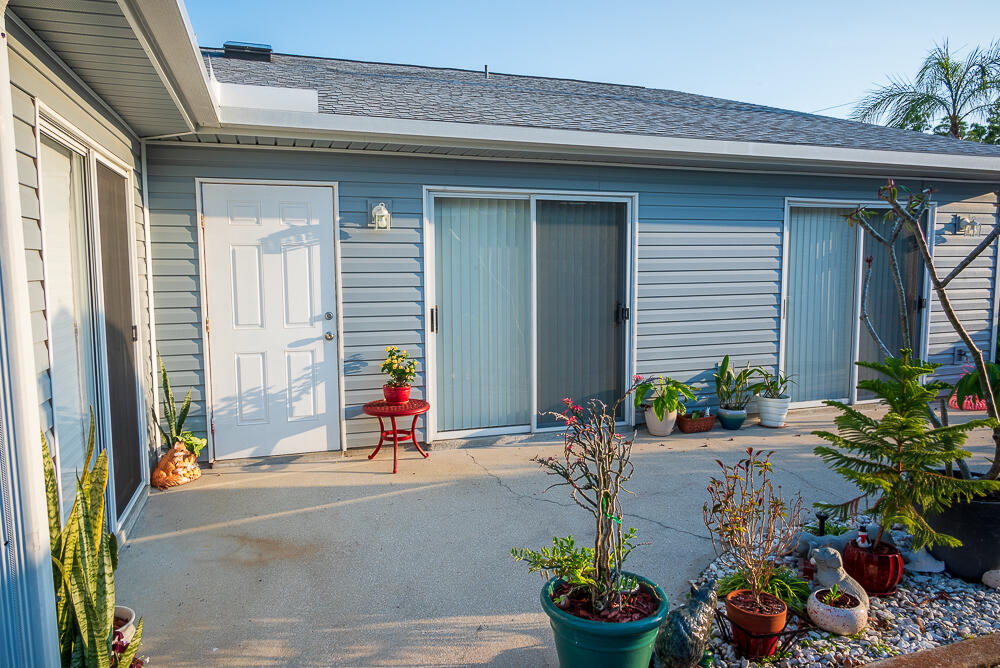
541;573;667;668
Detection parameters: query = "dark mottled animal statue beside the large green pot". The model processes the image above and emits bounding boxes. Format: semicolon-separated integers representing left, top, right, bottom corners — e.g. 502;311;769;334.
653;580;718;668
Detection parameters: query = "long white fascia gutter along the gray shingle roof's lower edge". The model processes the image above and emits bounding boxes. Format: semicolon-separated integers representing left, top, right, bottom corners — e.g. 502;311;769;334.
220;107;1000;176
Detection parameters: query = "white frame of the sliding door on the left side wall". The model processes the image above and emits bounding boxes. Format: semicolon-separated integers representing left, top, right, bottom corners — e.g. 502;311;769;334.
35;98;153;536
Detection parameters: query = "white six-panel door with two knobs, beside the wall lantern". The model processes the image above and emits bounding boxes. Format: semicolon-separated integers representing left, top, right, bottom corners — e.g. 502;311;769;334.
202;184;340;459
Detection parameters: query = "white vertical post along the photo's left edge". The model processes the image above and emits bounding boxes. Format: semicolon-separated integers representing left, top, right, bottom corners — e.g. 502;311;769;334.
0;5;60;666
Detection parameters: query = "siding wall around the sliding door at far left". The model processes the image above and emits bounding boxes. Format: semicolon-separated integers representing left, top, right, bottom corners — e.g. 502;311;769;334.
7;22;156;482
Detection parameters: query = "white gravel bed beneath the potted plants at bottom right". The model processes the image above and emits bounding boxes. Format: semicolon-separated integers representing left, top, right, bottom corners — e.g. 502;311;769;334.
698;531;1000;668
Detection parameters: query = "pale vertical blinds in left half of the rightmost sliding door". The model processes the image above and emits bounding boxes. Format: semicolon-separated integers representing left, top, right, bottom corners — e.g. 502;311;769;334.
785;207;857;401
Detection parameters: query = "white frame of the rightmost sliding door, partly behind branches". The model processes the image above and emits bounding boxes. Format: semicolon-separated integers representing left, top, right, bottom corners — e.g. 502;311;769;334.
778;197;937;408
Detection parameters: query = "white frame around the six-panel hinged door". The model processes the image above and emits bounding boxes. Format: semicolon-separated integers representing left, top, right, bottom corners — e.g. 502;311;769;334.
194;177;347;462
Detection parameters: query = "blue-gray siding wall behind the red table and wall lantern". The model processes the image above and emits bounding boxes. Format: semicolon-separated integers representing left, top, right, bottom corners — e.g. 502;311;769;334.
148;144;997;447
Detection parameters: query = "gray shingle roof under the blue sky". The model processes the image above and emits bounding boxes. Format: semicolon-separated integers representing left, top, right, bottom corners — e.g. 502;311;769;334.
202;49;1000;157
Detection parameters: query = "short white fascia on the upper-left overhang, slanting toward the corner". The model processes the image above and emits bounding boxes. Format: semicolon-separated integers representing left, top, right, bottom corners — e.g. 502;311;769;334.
118;0;219;128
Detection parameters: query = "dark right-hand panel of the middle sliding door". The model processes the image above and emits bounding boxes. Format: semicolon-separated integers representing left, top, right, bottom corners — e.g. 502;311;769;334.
535;200;625;426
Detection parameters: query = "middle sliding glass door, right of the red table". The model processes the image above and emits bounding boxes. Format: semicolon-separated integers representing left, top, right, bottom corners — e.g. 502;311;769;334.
429;195;629;435
